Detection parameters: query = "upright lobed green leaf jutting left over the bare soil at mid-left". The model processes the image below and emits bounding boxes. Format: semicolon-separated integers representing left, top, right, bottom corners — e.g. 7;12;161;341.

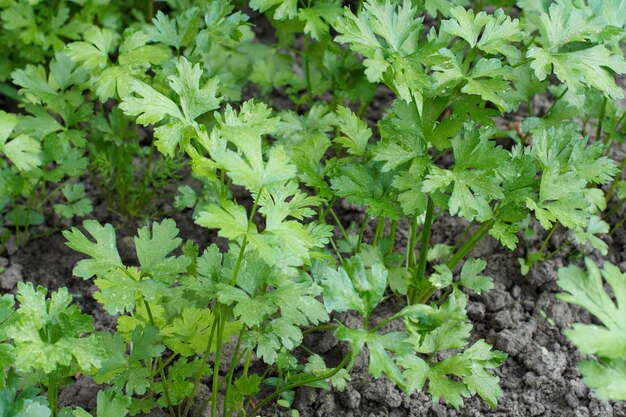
63;220;124;279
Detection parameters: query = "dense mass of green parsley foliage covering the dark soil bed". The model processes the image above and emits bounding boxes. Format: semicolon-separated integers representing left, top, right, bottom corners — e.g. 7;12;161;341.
0;0;626;417
